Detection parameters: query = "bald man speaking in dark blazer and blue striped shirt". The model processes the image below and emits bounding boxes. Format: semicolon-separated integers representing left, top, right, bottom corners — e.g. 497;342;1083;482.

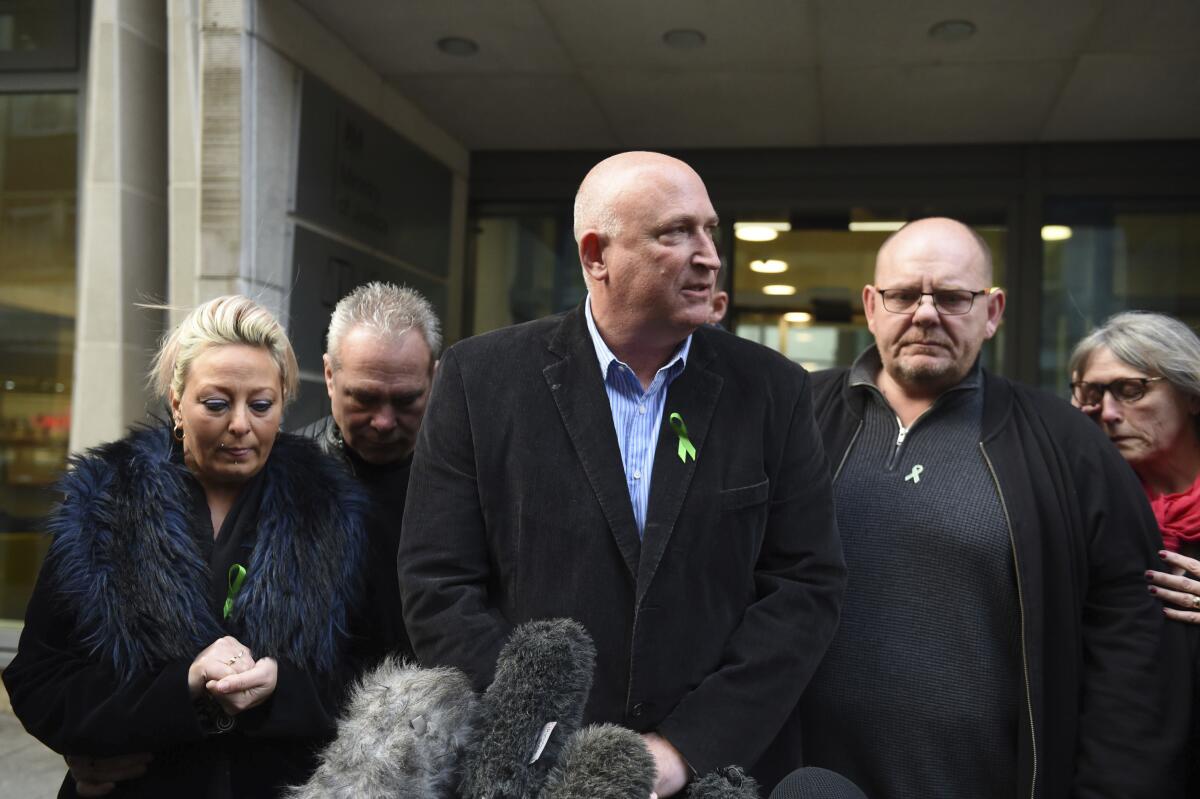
398;152;845;797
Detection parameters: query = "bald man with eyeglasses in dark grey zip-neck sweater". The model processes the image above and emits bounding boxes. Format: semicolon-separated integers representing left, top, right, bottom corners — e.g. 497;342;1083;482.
803;218;1183;799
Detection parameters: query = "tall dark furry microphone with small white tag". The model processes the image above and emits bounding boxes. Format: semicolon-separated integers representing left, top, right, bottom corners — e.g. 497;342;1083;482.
460;619;595;799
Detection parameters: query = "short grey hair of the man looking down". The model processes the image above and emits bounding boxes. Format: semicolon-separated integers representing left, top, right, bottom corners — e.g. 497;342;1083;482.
325;281;442;368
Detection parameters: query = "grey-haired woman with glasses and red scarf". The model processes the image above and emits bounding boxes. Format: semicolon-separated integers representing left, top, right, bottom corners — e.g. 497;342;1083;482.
1069;311;1200;624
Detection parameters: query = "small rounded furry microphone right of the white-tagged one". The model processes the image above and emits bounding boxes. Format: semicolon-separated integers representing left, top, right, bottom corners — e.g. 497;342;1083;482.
539;725;655;799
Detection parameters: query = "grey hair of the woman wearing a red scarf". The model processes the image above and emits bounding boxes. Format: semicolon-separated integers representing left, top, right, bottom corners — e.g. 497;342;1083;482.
1067;311;1200;419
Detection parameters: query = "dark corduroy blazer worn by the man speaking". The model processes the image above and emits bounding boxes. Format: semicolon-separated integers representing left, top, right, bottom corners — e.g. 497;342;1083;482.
398;306;845;786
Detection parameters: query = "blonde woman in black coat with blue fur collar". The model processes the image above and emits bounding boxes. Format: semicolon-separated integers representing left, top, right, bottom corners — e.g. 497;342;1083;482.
4;296;365;797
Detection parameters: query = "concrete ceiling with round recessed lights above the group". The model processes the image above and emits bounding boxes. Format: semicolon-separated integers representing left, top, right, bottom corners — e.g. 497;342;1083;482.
290;0;1200;150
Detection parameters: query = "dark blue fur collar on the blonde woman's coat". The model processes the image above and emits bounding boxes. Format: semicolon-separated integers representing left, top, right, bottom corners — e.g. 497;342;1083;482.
44;428;366;675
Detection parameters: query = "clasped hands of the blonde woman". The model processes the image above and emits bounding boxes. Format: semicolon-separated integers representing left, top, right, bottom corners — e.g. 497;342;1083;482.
187;636;280;716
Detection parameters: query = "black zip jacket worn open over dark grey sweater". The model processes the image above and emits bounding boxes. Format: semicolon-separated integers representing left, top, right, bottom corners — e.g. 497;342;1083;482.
806;370;1192;798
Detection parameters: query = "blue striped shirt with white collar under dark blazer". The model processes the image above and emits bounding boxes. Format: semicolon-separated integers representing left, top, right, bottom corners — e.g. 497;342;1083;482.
583;296;691;535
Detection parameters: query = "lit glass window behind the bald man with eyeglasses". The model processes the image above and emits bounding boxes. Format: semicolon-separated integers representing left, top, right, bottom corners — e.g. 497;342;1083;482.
732;209;1008;371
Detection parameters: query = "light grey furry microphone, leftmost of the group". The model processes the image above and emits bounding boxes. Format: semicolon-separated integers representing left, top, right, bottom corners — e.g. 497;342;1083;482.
284;659;479;799
